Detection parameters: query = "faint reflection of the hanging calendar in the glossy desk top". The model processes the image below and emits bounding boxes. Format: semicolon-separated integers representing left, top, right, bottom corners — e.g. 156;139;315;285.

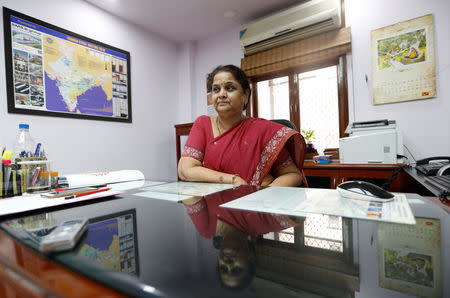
378;217;442;297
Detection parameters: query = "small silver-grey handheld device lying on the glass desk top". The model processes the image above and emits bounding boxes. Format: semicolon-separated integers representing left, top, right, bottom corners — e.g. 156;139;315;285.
39;218;88;253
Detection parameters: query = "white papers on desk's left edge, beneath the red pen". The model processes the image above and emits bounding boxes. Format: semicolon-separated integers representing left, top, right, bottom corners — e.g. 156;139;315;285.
0;190;122;216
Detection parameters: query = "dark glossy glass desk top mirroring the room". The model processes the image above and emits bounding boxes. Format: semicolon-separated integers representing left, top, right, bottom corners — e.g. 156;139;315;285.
0;182;450;297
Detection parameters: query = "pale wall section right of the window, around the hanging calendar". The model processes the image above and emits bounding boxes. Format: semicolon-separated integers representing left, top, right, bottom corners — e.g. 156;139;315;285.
345;0;450;159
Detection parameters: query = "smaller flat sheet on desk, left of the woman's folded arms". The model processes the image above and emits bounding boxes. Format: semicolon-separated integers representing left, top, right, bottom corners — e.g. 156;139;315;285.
135;181;235;202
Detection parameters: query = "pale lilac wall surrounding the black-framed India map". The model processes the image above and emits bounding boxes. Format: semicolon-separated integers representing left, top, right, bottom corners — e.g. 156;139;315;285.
0;0;179;180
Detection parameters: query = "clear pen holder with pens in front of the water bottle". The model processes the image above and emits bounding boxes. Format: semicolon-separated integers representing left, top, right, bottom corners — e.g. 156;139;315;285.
17;159;52;193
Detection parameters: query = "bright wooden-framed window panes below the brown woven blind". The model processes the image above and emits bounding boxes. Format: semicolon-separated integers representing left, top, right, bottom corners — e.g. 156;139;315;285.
252;59;348;151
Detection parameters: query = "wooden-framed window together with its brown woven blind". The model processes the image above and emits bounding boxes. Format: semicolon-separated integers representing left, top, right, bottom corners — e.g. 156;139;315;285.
241;24;351;149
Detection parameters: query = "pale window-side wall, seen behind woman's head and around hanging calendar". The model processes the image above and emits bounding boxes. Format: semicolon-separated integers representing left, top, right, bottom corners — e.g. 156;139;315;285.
191;0;450;159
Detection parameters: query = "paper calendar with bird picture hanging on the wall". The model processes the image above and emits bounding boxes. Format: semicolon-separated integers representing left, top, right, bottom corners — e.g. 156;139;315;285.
371;14;436;105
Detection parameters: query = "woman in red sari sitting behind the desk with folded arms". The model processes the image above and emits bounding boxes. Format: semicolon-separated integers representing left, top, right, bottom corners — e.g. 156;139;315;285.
178;65;305;186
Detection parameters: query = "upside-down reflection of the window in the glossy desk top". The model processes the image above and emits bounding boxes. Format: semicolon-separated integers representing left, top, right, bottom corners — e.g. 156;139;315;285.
255;214;359;297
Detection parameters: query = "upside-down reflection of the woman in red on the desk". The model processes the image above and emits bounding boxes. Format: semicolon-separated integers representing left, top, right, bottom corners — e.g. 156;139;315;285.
183;186;298;289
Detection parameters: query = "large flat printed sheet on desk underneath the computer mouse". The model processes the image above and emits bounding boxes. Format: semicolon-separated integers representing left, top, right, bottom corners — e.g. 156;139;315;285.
221;187;416;224
